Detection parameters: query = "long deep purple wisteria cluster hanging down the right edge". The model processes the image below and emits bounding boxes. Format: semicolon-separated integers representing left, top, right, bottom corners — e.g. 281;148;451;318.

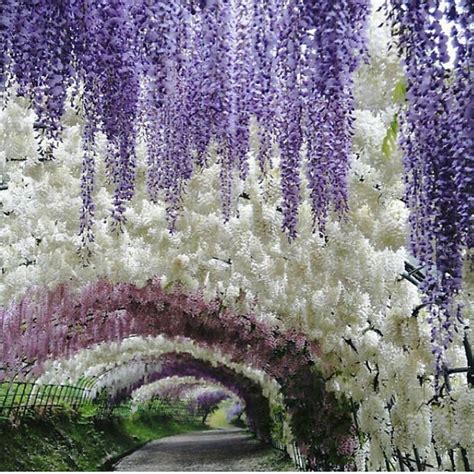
388;0;474;379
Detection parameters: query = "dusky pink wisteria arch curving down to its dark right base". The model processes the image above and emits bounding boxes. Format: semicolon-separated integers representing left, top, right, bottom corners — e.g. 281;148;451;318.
0;280;352;469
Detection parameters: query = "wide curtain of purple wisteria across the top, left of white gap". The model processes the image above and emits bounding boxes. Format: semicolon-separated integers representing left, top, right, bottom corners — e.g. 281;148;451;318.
0;0;369;247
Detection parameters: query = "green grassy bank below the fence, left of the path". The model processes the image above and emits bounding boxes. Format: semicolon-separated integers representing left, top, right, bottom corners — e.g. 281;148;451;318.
0;409;203;471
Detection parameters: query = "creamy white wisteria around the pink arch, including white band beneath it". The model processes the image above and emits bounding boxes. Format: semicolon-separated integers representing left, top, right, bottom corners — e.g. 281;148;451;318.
0;6;474;470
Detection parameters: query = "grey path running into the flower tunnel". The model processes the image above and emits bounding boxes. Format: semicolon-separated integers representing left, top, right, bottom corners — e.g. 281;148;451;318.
114;429;293;471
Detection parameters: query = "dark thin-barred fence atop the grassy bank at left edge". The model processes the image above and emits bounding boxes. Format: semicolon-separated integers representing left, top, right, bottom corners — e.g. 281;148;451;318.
0;381;90;419
